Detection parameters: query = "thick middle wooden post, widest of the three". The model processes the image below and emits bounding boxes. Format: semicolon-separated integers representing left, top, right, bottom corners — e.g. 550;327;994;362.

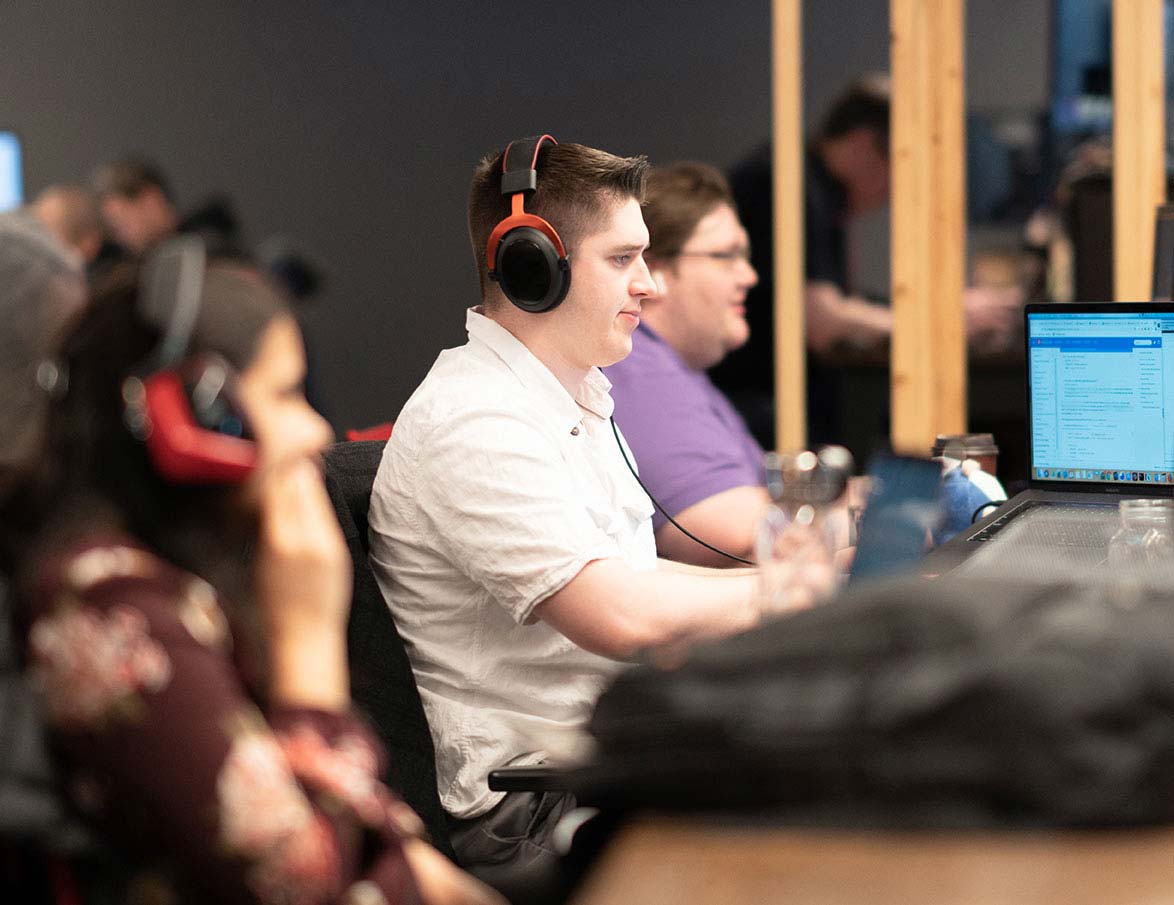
890;0;966;455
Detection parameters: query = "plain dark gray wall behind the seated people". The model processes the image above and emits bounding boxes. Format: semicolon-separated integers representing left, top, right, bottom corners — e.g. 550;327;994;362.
0;0;1043;427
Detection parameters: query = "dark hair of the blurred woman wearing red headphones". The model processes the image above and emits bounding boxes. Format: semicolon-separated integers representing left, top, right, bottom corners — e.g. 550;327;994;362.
8;264;284;602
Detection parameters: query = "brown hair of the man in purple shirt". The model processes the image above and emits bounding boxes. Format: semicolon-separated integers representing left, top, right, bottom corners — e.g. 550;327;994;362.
643;162;735;258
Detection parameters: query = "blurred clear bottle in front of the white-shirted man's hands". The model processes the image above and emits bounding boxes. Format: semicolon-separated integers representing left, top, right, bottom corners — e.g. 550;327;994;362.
757;446;852;614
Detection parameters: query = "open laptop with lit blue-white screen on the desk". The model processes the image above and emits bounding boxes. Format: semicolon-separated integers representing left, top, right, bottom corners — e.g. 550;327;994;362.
923;302;1174;579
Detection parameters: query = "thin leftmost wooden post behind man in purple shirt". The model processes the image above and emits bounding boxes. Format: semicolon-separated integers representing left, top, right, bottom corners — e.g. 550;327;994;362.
771;0;807;450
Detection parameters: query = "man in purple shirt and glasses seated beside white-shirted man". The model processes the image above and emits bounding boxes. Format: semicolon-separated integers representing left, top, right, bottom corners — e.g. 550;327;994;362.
605;163;768;566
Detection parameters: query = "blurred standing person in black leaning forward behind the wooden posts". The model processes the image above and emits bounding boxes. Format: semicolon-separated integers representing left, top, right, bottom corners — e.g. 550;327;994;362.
714;74;1023;448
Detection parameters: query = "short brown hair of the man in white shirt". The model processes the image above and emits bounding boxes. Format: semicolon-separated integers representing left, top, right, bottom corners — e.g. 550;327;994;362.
468;143;648;295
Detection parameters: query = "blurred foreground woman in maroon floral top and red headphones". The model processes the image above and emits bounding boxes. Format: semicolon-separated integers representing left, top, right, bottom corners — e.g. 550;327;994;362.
0;223;498;905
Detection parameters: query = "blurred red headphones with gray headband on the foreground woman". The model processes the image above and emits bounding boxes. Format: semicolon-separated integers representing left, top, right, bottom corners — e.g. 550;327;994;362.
122;236;257;484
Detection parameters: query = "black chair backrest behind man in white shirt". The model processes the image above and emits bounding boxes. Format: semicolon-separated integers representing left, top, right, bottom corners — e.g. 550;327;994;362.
324;440;456;860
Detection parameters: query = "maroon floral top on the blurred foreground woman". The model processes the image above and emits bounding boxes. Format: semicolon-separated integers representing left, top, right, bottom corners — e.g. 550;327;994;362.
27;542;419;905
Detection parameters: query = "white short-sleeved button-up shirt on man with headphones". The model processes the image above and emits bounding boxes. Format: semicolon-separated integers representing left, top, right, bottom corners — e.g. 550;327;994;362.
370;310;656;817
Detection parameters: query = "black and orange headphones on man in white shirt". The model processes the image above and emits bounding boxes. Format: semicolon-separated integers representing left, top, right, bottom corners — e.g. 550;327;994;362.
485;135;571;313
